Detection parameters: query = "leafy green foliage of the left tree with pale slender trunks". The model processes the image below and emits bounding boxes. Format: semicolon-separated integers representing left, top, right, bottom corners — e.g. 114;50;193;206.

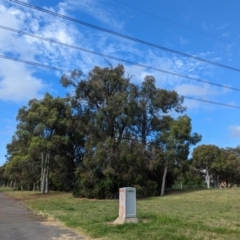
5;94;82;190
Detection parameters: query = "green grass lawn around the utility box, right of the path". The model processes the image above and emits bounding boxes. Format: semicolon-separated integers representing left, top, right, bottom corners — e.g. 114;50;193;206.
0;188;240;240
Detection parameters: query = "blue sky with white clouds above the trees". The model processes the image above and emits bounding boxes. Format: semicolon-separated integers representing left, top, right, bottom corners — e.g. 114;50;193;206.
0;0;240;165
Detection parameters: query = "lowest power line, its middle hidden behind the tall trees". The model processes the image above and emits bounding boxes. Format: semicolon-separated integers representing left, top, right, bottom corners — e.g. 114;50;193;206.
0;55;240;109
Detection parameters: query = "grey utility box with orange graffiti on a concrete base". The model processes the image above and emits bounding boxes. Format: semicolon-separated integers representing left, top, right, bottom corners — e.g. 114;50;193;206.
113;187;137;224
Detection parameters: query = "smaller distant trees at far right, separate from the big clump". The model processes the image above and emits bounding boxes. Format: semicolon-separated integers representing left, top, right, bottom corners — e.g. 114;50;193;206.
191;145;240;188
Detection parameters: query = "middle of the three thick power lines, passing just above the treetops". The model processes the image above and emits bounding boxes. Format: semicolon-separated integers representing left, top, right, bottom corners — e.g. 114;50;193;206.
0;25;240;91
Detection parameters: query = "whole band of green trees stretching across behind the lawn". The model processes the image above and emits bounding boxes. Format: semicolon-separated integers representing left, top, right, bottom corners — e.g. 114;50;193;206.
0;65;240;198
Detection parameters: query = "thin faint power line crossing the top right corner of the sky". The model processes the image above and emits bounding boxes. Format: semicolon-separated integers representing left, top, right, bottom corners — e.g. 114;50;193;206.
113;0;238;46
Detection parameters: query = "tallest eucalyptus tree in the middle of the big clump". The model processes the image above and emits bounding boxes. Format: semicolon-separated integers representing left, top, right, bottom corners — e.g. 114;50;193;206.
62;65;140;196
